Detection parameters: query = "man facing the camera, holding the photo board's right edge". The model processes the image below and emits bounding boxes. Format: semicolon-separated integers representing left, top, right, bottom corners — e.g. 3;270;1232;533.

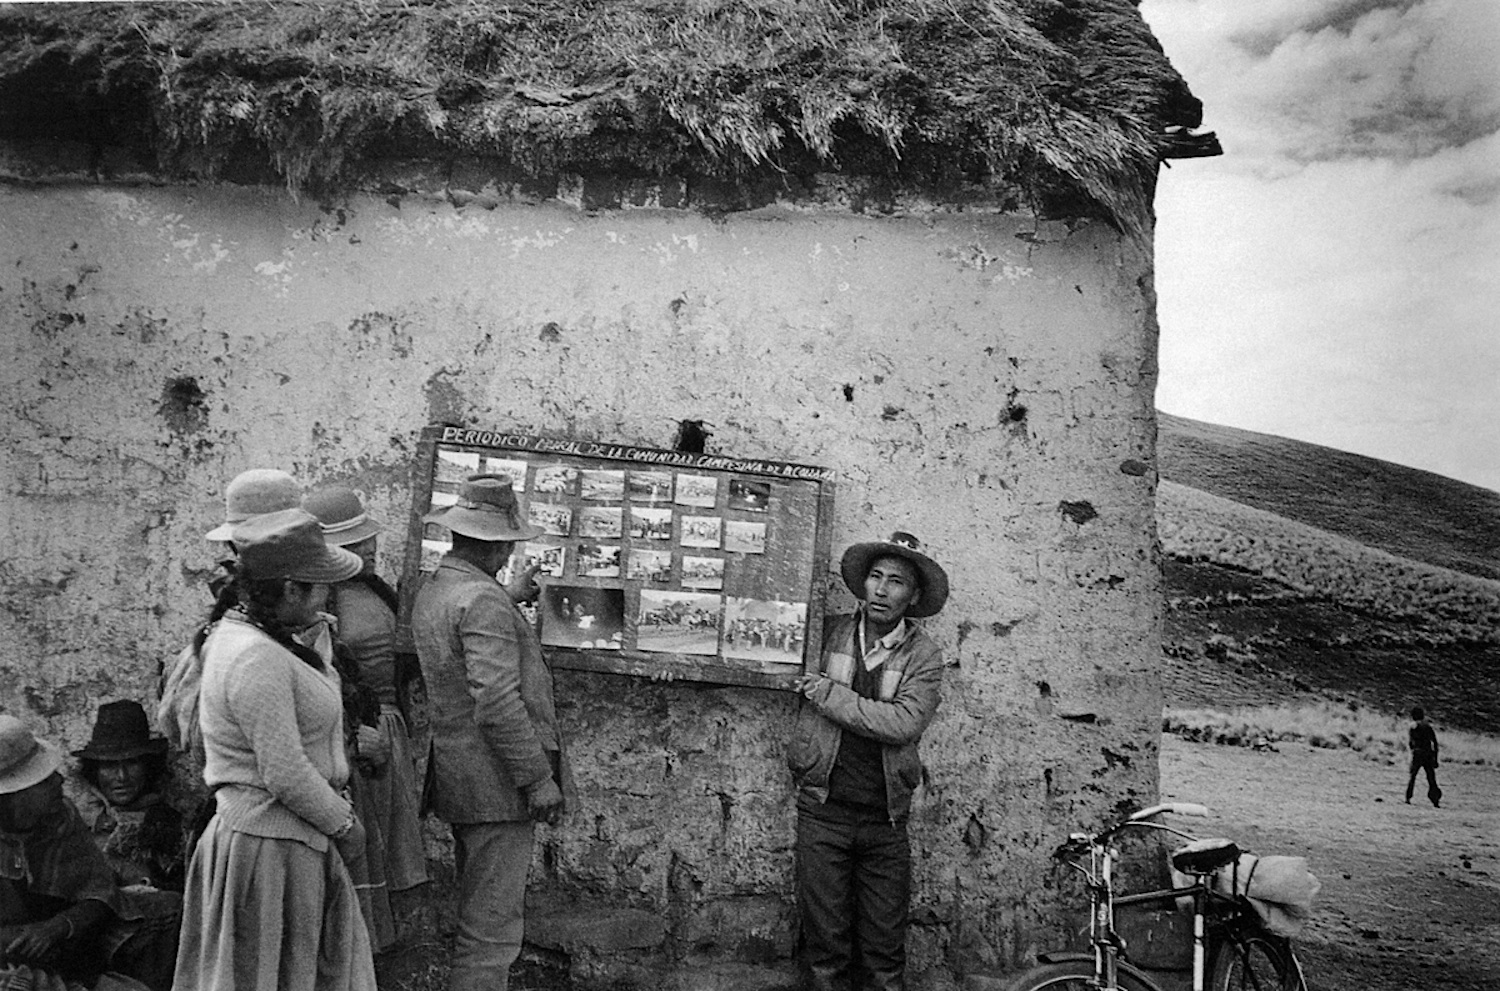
788;532;948;991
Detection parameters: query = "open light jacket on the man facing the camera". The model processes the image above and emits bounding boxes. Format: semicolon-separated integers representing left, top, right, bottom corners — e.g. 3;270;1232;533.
786;613;942;822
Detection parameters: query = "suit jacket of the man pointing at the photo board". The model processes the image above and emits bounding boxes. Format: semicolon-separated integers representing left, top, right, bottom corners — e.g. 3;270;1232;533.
411;555;572;823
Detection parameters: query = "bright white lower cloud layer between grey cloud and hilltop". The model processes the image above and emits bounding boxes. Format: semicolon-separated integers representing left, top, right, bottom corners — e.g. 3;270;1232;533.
1157;129;1500;489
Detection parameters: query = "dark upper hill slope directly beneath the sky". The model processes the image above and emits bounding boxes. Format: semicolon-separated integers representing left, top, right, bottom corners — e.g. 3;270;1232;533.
1157;414;1500;579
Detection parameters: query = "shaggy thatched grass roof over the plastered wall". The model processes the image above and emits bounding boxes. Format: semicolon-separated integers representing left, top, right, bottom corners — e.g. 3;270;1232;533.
0;0;1200;229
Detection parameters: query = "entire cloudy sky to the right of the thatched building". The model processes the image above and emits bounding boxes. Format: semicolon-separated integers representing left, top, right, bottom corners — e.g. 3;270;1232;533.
1140;0;1500;489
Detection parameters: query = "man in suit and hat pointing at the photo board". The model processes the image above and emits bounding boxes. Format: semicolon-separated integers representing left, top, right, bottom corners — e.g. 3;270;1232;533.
411;475;570;991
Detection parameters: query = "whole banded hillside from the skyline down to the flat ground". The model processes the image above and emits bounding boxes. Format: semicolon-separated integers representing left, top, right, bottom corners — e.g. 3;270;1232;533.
1157;417;1500;733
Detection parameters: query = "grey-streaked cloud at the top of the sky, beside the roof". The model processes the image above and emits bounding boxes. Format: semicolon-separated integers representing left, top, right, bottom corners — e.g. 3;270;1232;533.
1142;0;1500;165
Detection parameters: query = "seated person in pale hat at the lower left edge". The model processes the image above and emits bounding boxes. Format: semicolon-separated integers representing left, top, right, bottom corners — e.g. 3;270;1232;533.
0;714;182;988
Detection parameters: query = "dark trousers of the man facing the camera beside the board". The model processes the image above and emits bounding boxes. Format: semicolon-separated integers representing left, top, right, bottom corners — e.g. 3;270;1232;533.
797;796;912;991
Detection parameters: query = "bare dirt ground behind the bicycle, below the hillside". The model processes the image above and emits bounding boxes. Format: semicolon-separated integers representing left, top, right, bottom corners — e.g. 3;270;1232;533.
1161;736;1500;991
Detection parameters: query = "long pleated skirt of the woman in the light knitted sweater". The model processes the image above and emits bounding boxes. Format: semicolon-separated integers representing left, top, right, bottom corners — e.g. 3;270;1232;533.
174;819;375;991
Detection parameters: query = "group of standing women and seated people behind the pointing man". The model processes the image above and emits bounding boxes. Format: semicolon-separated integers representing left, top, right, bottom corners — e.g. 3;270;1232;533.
0;469;428;991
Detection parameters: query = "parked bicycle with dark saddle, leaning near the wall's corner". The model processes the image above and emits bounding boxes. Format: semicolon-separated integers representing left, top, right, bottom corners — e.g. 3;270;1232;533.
1007;802;1307;991
